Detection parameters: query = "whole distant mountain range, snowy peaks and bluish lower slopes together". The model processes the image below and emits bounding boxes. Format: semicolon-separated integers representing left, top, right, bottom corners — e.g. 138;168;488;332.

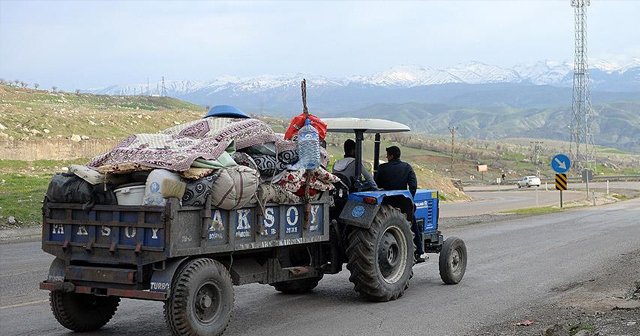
86;58;640;152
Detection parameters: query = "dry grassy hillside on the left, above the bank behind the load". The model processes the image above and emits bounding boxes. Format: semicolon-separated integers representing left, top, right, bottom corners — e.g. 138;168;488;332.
0;85;205;140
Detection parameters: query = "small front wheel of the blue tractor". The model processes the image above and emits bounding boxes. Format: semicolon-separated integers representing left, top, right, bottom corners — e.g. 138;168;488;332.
439;237;467;285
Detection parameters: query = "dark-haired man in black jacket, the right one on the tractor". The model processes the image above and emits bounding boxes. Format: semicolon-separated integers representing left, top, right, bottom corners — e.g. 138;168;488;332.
375;146;425;263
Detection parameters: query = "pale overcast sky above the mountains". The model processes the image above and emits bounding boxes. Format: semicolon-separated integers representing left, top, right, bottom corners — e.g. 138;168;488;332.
0;0;640;90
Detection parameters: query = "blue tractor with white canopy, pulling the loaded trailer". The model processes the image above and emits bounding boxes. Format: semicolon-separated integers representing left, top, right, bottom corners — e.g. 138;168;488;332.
324;118;467;301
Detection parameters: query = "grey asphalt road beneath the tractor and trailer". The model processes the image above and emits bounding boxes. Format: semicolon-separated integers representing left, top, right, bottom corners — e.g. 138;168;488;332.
0;199;640;336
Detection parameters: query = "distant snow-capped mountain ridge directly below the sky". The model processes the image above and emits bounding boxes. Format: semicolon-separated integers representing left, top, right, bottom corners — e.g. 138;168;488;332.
91;58;640;98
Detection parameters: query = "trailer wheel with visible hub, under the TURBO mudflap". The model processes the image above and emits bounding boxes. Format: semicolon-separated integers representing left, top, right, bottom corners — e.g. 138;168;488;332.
164;258;234;335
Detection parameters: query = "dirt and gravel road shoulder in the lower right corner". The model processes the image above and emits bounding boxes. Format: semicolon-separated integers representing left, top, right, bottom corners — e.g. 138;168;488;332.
471;250;640;336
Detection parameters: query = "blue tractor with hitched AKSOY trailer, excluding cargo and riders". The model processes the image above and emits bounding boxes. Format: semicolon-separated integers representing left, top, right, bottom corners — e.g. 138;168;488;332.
40;117;467;336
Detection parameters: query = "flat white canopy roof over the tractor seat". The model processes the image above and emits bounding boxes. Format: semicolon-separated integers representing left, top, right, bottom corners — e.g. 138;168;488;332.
322;118;411;133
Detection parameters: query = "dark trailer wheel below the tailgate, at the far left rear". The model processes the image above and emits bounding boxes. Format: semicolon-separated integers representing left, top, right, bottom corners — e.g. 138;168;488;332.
49;291;120;332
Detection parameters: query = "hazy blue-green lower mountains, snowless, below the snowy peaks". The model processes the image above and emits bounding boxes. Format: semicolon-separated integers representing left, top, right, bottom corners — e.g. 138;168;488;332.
344;99;640;153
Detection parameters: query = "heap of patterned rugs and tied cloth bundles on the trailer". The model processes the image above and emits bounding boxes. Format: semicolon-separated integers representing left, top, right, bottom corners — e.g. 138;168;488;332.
87;118;339;209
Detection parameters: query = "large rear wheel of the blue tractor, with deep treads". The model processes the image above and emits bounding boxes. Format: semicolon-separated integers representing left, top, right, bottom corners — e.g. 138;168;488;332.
347;205;415;301
